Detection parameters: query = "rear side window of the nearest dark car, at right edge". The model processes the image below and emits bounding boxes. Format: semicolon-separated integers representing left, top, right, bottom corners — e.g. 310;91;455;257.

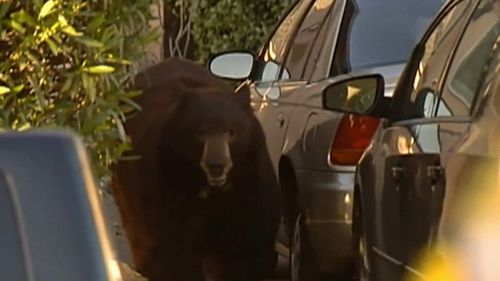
437;0;500;116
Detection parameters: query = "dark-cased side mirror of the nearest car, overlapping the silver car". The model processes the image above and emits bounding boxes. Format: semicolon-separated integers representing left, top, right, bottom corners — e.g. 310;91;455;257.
323;74;387;118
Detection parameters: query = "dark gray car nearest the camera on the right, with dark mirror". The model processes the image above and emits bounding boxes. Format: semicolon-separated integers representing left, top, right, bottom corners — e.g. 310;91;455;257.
324;0;500;281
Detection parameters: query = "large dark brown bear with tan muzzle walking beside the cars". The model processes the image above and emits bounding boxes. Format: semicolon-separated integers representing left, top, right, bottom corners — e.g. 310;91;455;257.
112;58;281;281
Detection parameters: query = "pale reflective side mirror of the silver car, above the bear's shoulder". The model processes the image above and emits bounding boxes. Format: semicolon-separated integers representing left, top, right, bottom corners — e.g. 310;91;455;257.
208;51;255;80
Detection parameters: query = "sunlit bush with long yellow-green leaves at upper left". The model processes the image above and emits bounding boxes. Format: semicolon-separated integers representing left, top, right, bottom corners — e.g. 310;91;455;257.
0;0;159;183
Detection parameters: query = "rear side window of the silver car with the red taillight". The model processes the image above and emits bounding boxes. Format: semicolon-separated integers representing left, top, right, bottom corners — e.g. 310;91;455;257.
281;0;334;80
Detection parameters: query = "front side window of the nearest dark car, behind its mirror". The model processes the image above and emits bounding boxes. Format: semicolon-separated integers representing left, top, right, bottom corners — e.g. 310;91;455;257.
393;1;471;120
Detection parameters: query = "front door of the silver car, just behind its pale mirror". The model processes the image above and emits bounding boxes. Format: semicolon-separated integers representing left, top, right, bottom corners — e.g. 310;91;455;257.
237;0;312;168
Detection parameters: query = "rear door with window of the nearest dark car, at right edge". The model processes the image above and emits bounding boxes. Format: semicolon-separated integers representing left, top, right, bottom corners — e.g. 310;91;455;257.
436;0;500;274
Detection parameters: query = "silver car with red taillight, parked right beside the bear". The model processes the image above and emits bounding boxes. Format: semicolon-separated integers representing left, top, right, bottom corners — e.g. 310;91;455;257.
209;0;442;280
